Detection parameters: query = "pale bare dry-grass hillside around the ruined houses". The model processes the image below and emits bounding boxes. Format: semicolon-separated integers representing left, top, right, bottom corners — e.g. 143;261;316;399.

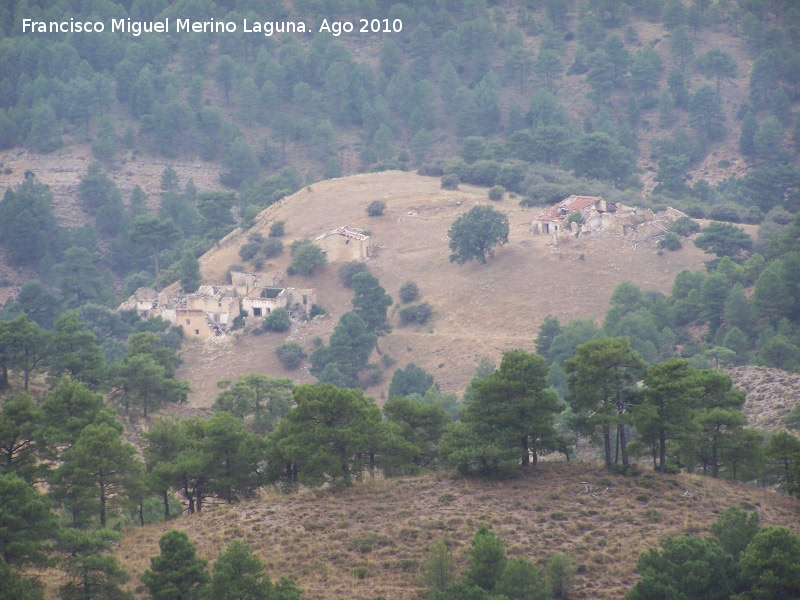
173;172;708;407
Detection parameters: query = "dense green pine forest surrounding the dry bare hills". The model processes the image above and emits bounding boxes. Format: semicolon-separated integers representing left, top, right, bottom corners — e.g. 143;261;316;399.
0;0;800;600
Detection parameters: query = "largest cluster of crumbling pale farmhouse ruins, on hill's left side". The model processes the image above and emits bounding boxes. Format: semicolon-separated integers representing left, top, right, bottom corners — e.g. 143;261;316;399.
119;271;316;339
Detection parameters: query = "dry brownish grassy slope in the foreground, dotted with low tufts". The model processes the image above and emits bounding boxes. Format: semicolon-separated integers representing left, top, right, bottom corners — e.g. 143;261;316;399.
108;462;800;600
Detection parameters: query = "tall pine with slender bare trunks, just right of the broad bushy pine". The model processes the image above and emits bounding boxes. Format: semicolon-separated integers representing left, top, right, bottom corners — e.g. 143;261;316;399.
564;338;646;468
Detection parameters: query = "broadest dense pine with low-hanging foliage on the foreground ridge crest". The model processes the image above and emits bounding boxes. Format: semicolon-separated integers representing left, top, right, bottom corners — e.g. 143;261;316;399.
440;350;566;477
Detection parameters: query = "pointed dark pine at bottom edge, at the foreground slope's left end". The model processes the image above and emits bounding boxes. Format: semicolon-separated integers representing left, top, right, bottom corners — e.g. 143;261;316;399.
142;529;210;600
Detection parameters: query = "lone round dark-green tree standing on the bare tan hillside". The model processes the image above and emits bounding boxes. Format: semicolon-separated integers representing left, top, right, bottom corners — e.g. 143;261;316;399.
447;206;509;265
